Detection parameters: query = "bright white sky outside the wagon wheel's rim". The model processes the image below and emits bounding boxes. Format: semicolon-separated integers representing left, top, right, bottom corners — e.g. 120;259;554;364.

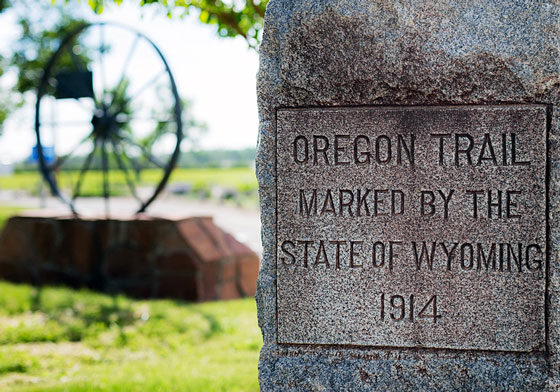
0;2;258;161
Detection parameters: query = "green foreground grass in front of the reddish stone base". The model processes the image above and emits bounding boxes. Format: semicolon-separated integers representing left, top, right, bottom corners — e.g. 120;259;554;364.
0;282;262;392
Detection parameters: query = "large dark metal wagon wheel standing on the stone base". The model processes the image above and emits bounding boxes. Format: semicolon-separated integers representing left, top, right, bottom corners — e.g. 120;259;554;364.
35;22;182;215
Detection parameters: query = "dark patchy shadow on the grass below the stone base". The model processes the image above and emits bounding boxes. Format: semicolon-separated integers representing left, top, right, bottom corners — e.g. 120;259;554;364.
4;286;226;347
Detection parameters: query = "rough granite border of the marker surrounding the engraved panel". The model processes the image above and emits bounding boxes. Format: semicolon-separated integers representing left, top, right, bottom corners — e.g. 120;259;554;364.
257;0;560;391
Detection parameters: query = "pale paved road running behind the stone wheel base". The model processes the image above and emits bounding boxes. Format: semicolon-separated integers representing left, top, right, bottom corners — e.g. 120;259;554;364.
0;191;262;255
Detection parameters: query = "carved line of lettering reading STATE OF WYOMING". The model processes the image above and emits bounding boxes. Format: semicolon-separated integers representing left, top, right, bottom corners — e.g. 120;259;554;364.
278;239;544;273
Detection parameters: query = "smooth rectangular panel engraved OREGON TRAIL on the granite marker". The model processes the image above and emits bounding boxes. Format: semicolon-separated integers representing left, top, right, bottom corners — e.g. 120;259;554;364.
276;105;548;352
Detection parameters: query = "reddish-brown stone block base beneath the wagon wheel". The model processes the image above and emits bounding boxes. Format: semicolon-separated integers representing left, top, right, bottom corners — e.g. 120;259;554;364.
0;216;259;301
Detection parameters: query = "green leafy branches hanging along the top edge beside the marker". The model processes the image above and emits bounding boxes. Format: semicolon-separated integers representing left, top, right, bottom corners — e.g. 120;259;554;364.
69;0;268;49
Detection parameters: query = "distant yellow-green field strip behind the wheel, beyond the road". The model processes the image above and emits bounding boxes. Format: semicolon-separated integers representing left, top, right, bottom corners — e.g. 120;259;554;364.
0;168;257;196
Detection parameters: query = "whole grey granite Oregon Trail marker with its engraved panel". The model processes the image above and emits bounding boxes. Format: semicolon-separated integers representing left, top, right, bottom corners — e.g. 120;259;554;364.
257;0;560;391
